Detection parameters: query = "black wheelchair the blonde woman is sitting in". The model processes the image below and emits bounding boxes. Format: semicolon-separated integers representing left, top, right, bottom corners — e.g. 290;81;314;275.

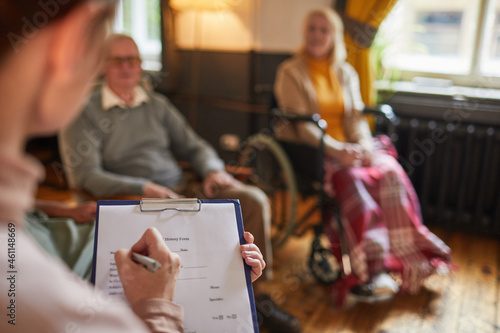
239;104;398;284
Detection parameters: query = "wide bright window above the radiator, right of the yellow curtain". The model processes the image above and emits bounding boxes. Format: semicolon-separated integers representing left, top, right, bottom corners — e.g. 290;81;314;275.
374;0;500;88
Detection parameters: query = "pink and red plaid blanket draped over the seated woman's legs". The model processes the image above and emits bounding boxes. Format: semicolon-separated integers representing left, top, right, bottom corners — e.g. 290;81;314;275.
324;137;450;304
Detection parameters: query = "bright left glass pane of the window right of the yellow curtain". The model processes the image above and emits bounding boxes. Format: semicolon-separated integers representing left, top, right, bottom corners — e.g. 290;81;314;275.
379;0;480;74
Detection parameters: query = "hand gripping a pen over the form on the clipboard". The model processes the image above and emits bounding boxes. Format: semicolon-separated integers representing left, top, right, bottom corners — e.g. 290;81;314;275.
115;228;181;304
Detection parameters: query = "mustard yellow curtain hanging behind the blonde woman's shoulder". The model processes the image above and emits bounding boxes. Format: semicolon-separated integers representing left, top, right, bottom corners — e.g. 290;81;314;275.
345;0;397;105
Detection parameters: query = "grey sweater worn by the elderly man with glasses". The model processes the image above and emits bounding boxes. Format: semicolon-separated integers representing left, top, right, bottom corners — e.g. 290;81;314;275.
59;89;224;197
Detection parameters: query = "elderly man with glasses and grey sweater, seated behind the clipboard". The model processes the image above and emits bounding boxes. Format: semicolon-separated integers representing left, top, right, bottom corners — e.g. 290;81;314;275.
60;35;300;332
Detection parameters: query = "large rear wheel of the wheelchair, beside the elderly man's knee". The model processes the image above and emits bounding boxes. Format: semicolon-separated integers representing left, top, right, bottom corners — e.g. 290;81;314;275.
239;133;297;247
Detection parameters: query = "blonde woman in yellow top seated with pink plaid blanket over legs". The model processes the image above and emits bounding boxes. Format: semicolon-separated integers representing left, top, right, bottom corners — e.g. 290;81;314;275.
274;8;456;303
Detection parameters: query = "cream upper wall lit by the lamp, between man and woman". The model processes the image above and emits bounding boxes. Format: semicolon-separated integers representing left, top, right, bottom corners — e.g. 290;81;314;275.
175;0;332;52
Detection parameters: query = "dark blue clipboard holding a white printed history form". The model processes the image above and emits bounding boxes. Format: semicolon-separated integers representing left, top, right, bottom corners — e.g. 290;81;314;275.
91;198;259;333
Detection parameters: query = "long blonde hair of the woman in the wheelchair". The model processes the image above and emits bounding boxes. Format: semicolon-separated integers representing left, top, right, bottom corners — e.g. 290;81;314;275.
301;7;347;65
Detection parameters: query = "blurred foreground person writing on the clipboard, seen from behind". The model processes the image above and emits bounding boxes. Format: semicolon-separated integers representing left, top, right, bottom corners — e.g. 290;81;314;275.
0;0;265;333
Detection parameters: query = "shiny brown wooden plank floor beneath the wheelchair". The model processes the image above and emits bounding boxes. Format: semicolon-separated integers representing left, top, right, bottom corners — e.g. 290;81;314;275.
259;229;500;333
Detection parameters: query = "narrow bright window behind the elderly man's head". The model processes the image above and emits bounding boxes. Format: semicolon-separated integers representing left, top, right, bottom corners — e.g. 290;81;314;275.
113;0;162;71
